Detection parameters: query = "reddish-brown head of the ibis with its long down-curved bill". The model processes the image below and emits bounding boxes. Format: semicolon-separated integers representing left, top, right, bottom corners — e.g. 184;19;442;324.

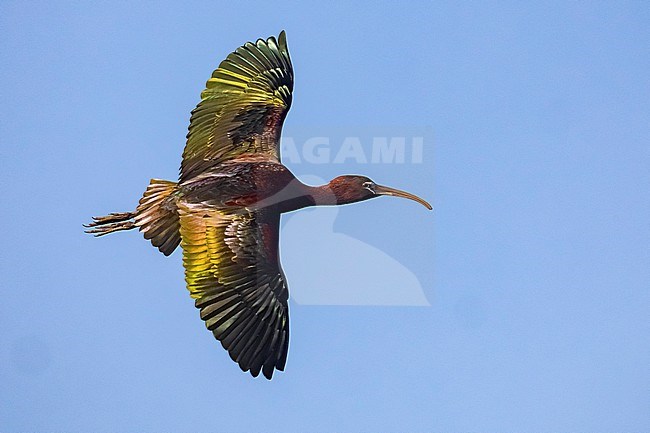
328;175;433;210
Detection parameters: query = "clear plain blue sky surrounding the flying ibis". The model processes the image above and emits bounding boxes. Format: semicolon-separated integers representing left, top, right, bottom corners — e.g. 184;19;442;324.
0;1;650;433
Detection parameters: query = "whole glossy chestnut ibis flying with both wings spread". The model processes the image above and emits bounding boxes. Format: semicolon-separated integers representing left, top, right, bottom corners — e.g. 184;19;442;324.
86;31;431;379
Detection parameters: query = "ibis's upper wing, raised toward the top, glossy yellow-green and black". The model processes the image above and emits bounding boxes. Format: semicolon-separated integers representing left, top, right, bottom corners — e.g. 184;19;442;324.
180;31;293;183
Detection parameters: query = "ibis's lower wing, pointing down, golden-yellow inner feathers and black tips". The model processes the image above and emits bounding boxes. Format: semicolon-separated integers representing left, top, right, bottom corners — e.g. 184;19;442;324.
179;207;289;379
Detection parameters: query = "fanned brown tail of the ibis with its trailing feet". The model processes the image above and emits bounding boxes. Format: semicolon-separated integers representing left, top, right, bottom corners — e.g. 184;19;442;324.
84;179;181;256
